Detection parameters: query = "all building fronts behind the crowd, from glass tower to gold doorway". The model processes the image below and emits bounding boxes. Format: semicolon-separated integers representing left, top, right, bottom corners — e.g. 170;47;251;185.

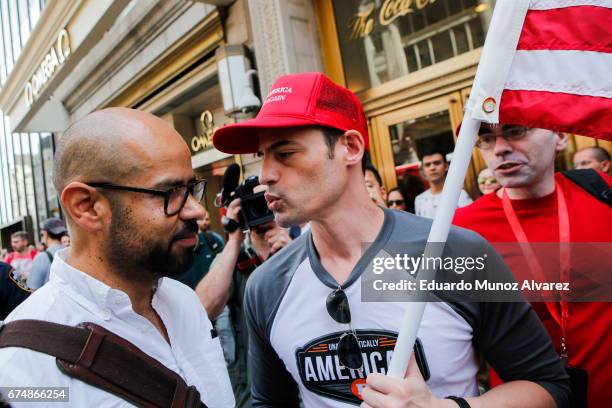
0;0;612;245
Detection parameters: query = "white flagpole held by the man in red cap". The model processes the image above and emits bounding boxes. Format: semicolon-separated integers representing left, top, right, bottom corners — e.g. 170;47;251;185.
387;0;530;378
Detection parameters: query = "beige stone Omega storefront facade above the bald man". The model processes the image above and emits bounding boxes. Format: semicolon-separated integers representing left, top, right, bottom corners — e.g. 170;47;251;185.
0;0;249;239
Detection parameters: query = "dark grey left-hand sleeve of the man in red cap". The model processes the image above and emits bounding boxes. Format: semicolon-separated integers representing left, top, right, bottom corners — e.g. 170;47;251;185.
244;271;299;408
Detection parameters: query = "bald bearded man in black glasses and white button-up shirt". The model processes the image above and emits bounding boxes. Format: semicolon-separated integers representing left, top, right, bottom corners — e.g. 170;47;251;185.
0;108;234;407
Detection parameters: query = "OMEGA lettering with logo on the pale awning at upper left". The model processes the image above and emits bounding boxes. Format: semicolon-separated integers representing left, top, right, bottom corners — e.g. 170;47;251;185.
24;29;72;106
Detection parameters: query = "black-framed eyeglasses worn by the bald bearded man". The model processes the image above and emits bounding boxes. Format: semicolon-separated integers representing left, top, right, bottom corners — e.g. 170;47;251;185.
86;180;206;217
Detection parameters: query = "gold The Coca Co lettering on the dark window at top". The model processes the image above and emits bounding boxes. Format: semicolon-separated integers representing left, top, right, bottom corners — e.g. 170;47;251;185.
348;0;436;40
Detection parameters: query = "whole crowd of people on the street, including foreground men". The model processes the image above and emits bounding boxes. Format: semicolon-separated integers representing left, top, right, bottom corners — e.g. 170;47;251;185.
0;73;612;408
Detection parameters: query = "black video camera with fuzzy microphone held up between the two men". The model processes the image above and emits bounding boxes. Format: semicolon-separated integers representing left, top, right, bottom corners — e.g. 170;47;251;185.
219;163;274;230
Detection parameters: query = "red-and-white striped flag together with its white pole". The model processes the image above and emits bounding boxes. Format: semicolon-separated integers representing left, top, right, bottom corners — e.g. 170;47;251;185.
388;0;612;378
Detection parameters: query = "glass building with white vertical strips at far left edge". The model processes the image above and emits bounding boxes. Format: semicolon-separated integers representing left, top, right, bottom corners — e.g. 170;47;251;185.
0;0;55;247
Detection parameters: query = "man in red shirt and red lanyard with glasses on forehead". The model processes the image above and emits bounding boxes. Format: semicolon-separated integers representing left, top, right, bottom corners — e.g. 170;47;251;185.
454;124;612;407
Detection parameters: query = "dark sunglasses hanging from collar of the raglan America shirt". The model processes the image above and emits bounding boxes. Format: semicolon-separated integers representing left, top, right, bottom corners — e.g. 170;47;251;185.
325;288;363;370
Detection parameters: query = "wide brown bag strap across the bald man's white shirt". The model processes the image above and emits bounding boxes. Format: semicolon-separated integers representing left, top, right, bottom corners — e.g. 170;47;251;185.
0;320;206;408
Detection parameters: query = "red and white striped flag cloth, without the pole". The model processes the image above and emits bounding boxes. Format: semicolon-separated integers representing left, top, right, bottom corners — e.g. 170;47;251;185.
468;0;612;140
